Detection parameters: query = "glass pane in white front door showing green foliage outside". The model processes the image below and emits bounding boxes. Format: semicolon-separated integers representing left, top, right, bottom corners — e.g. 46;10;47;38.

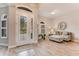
20;16;27;34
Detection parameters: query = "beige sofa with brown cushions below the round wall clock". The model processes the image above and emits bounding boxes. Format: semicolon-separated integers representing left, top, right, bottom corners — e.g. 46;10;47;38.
48;31;73;42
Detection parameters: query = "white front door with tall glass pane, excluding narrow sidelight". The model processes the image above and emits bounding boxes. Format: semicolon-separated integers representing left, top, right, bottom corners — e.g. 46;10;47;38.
16;15;31;43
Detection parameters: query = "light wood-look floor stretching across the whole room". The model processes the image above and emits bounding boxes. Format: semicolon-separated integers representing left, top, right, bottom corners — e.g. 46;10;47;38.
0;40;79;56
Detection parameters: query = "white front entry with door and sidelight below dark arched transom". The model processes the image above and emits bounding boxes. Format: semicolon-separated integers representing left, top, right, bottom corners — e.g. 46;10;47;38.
16;6;33;45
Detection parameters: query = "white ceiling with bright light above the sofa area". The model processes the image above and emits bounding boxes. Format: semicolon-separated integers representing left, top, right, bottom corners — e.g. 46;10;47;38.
39;3;79;18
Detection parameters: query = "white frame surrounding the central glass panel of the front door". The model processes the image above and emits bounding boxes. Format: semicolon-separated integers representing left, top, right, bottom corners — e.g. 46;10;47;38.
16;9;33;45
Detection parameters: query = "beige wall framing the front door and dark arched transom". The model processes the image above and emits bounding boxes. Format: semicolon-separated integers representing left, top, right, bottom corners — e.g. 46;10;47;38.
8;4;38;48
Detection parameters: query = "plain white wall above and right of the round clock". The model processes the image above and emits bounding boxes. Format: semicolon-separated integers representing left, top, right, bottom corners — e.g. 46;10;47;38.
54;11;79;39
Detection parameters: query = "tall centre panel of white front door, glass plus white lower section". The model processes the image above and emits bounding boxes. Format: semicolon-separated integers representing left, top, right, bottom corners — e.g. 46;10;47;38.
19;16;27;40
